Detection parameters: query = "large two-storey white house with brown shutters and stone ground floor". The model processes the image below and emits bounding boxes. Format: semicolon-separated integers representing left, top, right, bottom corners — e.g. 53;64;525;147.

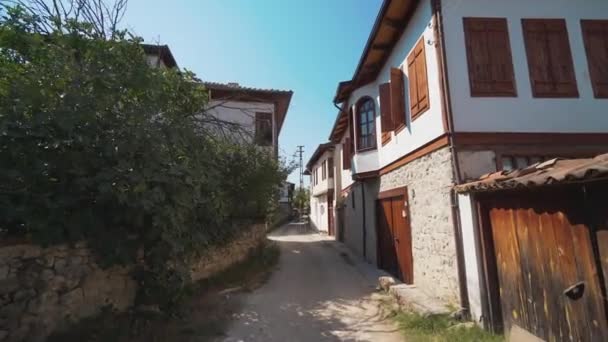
311;0;608;340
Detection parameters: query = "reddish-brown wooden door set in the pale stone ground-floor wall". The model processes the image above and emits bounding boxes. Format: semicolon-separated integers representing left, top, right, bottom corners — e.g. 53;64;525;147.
378;192;414;284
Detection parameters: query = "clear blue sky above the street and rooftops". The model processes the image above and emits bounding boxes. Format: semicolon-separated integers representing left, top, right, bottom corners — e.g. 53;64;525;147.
122;0;381;183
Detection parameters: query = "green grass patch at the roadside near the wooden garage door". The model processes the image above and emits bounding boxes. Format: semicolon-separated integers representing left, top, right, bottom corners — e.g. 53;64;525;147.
394;312;504;342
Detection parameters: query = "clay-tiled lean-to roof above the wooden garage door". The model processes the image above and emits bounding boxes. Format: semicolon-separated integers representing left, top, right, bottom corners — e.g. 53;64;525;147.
454;153;608;192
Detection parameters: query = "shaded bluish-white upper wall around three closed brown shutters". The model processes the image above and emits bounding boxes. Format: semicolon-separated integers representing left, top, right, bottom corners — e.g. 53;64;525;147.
442;0;608;133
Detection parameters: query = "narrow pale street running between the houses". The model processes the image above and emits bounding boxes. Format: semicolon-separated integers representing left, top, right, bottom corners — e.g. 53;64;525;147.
221;224;403;342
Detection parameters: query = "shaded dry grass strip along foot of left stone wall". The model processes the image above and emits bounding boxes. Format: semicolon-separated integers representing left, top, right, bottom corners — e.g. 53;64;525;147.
47;242;280;342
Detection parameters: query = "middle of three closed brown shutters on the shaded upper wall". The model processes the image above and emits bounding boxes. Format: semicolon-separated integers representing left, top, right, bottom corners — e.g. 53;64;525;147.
522;19;578;97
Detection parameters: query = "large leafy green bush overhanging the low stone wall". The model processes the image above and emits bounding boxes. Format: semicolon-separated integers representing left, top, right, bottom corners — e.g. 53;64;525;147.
0;2;286;308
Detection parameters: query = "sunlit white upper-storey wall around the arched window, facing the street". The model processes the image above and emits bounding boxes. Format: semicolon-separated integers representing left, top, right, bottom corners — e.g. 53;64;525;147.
349;0;444;173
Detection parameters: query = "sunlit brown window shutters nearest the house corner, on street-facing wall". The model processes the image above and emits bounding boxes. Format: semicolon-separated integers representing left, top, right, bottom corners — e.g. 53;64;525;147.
407;38;429;120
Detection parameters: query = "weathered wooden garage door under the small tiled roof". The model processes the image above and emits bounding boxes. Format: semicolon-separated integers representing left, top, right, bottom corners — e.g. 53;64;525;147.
489;196;608;341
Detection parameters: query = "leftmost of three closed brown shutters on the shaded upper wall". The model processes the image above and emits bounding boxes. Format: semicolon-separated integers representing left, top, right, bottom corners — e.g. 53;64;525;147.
464;18;517;96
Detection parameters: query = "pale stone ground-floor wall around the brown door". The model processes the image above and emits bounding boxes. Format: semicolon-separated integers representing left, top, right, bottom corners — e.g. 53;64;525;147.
380;148;459;304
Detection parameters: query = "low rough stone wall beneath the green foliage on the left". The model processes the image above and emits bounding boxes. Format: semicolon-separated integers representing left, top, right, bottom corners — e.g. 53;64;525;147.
0;224;266;342
